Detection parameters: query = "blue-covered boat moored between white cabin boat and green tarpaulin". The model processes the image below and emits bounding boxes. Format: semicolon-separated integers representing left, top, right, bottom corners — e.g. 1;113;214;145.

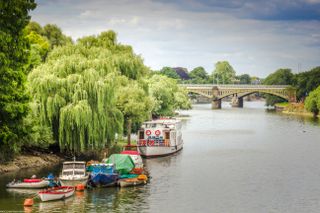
89;163;119;187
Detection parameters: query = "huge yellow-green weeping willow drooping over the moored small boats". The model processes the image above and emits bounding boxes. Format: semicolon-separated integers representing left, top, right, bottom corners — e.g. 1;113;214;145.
28;31;148;152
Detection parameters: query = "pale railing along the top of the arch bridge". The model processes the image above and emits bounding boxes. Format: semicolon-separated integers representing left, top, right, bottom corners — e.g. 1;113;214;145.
179;84;290;89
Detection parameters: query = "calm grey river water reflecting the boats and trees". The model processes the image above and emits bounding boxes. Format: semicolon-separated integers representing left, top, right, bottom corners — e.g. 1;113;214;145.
0;102;320;213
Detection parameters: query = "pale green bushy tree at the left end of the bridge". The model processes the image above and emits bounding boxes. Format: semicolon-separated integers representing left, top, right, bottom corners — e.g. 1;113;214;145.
148;75;191;116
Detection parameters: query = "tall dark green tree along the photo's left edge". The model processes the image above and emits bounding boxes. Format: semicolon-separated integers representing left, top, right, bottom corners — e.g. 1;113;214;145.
0;0;36;162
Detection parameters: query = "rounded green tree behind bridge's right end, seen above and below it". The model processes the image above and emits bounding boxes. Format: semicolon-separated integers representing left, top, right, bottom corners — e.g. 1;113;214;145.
263;69;293;106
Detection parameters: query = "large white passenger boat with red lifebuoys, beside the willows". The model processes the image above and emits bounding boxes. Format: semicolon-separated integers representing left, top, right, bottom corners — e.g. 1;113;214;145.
138;118;183;157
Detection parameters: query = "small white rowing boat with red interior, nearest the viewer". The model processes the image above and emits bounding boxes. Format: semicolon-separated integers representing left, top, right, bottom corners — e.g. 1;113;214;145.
38;186;75;201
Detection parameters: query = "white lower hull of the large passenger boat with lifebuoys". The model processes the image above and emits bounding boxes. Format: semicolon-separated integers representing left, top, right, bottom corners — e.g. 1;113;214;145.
138;144;183;158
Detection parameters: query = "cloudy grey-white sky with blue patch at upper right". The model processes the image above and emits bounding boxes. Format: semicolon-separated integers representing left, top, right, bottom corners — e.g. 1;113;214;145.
31;0;320;78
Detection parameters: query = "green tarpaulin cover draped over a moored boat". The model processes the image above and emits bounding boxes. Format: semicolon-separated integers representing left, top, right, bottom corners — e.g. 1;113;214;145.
106;154;134;175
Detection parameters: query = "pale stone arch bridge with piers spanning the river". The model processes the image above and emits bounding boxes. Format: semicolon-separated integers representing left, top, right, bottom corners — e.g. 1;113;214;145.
180;84;296;109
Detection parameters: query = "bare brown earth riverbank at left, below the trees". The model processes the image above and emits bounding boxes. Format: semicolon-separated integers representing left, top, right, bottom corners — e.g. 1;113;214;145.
0;152;64;174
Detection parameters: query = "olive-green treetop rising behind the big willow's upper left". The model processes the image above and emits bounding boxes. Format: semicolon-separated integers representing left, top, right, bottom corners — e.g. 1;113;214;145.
43;24;73;49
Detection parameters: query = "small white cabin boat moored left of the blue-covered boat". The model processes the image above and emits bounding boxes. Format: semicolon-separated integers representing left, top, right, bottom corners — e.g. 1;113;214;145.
59;161;89;186
